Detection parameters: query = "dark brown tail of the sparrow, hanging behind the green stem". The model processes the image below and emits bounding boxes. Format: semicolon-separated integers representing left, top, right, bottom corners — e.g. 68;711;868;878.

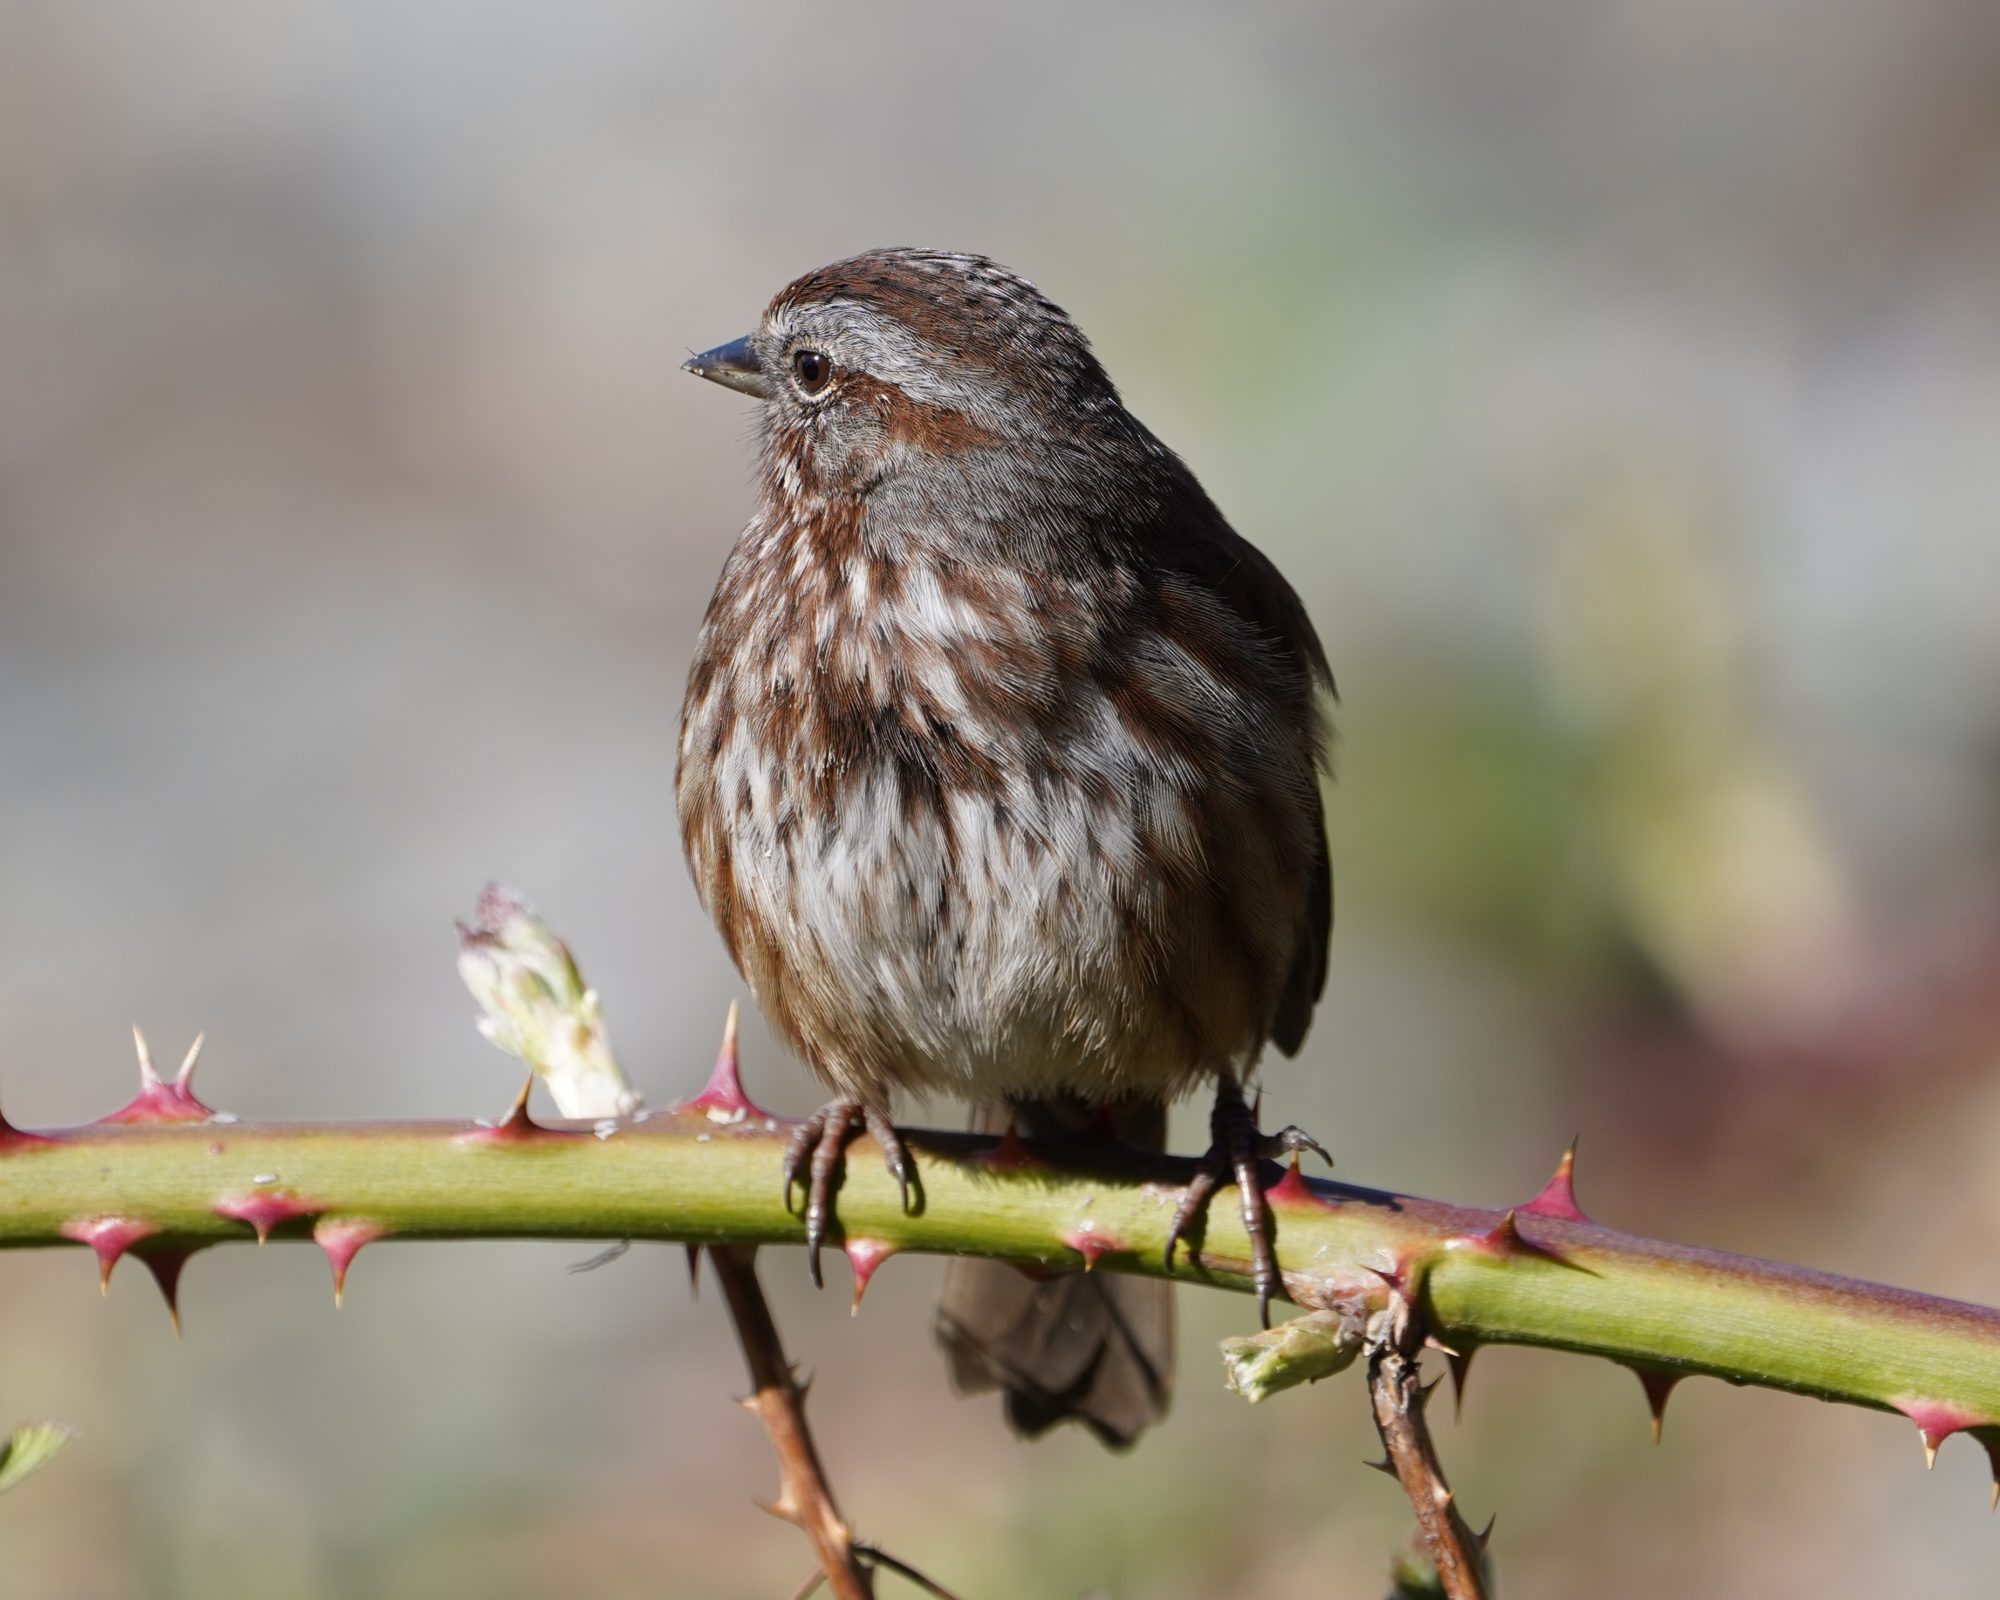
936;1098;1174;1448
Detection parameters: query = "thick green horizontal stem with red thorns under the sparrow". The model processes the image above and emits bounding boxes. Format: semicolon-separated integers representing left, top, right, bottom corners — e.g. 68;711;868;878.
0;1052;2000;1502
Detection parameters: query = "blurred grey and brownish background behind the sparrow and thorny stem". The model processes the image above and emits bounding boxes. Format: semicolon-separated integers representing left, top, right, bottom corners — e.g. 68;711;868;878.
0;0;2000;1600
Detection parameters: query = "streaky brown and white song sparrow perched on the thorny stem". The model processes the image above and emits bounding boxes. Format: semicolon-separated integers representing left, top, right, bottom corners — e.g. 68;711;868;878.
678;250;1332;1444
